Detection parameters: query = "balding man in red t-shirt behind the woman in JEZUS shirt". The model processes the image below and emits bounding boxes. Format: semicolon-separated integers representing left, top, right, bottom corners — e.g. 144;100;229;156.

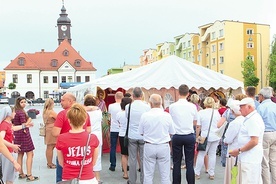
52;92;91;182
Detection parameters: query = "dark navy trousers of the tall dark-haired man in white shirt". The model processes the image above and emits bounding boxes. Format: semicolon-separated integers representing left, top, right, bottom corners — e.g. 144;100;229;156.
172;134;195;184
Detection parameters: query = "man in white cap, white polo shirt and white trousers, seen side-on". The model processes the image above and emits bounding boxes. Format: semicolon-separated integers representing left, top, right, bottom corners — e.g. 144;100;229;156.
229;97;265;184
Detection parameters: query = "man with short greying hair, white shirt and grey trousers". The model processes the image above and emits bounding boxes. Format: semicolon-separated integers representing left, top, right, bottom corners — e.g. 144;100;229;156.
125;87;150;184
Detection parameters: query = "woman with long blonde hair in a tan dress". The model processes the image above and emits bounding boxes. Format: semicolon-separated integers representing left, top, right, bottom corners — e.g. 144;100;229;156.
42;98;57;169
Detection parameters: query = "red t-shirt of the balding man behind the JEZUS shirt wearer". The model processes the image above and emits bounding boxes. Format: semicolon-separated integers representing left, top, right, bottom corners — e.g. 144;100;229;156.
55;108;91;134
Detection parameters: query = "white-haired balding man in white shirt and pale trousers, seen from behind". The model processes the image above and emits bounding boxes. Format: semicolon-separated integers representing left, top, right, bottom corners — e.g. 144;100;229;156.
139;94;175;184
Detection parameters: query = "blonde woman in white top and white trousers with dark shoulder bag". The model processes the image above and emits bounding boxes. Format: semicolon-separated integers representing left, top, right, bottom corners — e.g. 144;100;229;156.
195;97;220;180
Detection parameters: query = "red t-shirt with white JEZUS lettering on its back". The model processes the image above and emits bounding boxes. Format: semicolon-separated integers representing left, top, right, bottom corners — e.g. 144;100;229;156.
56;131;99;180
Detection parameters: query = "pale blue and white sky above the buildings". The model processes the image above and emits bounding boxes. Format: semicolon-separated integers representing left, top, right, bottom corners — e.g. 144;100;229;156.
0;0;276;78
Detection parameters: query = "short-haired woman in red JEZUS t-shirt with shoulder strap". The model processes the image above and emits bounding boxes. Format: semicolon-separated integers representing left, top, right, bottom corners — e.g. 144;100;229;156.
56;103;99;184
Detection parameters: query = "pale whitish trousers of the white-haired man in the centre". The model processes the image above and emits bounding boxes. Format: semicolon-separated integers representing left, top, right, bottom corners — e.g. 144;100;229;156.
143;143;171;184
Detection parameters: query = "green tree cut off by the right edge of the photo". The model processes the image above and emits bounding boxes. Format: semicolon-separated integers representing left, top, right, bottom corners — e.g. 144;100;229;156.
268;35;276;89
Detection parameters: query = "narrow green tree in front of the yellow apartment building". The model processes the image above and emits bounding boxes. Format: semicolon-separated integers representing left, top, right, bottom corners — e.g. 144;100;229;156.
241;53;260;87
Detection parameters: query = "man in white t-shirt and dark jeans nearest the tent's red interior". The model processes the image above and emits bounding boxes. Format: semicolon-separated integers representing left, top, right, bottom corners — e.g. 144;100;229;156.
108;91;124;171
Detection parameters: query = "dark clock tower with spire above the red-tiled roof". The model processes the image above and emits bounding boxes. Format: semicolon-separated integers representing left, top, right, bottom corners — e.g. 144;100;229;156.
57;4;72;45
